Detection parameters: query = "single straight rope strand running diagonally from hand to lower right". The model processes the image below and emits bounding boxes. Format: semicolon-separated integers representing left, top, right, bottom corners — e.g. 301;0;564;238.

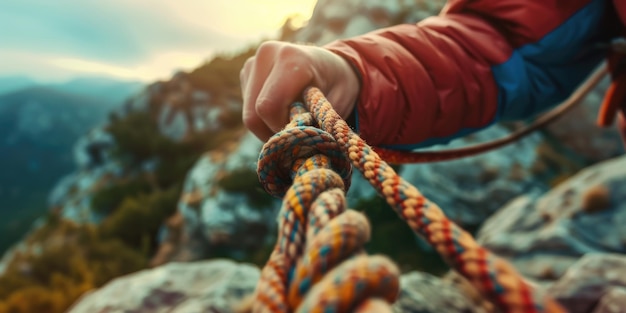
305;88;565;312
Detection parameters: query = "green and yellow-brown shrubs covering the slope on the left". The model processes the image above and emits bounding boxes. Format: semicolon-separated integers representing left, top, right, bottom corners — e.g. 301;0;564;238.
0;45;256;313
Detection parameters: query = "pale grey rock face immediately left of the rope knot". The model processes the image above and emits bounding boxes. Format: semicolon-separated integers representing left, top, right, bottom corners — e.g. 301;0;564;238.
160;133;280;261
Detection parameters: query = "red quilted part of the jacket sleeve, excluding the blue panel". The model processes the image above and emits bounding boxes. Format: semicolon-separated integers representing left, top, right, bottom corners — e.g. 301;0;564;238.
325;0;621;146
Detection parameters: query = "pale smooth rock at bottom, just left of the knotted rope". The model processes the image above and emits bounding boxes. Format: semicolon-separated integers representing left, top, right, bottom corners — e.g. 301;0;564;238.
68;260;260;313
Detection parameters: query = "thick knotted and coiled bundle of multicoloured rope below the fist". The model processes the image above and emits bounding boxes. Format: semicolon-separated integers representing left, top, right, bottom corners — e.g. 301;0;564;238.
252;104;399;312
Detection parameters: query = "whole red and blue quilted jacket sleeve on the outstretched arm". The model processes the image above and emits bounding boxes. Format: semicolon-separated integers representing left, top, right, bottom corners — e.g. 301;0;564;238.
325;0;626;150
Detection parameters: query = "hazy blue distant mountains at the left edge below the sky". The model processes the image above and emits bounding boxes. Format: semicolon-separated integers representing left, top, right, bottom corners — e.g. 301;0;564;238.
0;77;143;254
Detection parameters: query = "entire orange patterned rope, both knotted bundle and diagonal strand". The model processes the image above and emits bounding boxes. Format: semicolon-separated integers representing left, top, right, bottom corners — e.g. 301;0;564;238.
253;88;564;312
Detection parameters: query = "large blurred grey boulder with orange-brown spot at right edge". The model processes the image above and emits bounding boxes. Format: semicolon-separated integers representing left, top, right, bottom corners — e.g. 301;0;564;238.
477;156;626;280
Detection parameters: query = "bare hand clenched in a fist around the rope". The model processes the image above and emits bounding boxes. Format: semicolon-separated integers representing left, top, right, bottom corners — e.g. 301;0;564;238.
240;41;359;141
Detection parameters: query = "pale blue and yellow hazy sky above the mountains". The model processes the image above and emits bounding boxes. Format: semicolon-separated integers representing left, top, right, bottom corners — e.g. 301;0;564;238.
0;0;316;81
